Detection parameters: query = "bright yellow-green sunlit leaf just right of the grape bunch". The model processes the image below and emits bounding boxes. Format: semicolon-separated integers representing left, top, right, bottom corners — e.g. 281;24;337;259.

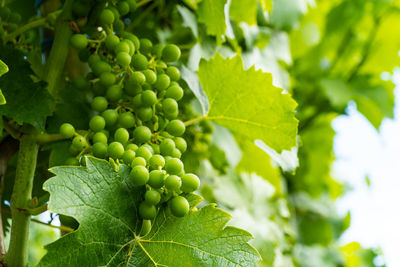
198;54;298;152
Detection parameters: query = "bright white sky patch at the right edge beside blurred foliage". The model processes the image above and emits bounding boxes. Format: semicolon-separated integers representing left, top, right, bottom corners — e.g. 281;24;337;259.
333;72;400;267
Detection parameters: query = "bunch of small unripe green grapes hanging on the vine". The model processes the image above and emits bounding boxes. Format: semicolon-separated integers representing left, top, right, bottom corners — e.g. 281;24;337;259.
60;1;200;228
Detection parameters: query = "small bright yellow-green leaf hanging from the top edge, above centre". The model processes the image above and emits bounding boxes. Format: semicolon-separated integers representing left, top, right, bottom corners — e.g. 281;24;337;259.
197;0;227;40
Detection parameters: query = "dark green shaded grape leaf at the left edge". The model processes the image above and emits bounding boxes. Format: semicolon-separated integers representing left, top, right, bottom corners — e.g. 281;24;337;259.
0;46;52;130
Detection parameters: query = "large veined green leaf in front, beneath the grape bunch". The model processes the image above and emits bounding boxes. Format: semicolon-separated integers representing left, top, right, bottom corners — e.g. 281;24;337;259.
39;157;259;266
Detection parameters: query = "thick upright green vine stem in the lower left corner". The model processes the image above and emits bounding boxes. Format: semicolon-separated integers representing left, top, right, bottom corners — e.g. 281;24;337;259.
5;135;39;267
